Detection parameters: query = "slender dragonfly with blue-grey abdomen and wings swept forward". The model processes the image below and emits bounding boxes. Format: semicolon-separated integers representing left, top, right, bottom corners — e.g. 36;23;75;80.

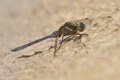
11;16;111;56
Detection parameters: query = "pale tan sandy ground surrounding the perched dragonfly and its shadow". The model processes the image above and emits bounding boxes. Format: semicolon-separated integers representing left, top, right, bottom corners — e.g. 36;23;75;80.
0;0;120;80
